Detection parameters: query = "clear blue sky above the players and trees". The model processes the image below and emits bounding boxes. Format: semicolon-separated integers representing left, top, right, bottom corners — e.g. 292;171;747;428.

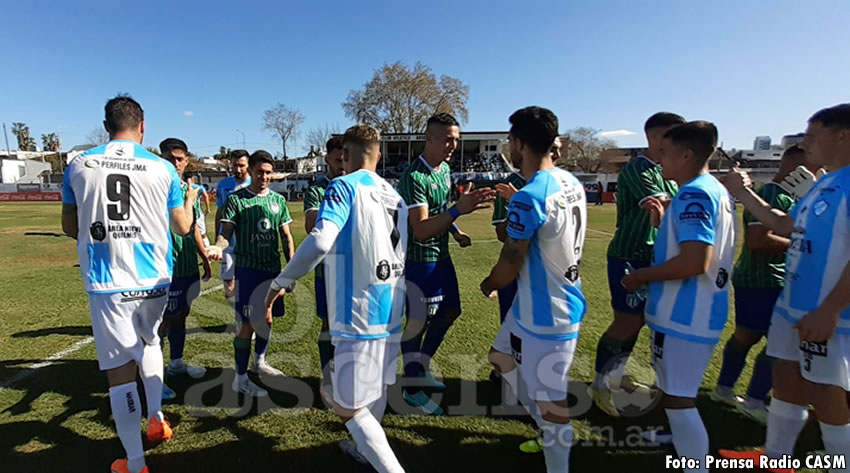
0;0;850;155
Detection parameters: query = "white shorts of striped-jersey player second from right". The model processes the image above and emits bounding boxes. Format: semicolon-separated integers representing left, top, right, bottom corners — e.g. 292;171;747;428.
650;331;716;398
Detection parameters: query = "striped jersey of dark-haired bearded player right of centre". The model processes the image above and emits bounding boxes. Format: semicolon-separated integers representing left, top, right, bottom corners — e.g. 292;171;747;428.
507;168;587;340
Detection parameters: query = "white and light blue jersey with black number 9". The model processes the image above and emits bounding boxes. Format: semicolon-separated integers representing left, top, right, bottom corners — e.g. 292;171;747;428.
62;140;183;293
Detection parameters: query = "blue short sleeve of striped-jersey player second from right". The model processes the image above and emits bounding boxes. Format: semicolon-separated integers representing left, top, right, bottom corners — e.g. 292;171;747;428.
671;188;717;245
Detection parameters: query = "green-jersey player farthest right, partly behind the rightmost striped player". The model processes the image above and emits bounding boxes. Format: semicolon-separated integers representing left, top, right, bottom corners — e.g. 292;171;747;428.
711;146;817;424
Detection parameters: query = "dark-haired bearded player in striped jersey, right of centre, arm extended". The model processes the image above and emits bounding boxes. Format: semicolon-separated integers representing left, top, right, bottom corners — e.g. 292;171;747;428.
481;107;587;473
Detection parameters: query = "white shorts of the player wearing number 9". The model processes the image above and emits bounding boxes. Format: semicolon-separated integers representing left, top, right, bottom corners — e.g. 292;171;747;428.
89;287;168;371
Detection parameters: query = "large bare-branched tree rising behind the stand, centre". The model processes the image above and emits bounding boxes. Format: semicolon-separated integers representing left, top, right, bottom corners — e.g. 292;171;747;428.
342;62;469;133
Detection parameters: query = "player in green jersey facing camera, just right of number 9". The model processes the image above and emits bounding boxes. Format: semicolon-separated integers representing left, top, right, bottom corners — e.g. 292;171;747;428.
210;150;295;397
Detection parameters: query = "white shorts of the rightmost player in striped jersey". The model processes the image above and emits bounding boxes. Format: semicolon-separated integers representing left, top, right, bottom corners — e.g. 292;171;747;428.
767;312;850;391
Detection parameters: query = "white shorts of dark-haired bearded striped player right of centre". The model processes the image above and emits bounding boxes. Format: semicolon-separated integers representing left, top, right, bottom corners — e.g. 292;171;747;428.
493;314;578;402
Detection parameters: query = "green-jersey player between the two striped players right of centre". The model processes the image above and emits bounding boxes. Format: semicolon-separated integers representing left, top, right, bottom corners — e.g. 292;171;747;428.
590;112;685;417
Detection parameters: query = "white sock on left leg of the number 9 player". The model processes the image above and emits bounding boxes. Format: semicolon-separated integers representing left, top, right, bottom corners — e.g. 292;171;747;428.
109;381;144;473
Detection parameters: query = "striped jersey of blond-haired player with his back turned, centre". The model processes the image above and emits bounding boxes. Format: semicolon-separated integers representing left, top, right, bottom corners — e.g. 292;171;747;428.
316;169;408;339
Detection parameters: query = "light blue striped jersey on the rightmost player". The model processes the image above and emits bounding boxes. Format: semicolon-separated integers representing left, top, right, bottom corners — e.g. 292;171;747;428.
774;166;850;333
